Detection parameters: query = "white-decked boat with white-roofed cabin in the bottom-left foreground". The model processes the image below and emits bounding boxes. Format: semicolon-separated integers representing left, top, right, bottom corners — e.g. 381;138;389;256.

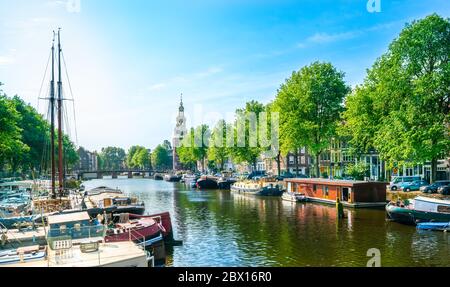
0;212;152;267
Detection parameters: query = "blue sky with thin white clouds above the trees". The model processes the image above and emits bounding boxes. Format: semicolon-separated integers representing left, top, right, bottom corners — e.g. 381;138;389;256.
0;0;450;153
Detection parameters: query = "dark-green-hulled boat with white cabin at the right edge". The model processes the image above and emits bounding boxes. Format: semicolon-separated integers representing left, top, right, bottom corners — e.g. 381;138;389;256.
386;196;450;225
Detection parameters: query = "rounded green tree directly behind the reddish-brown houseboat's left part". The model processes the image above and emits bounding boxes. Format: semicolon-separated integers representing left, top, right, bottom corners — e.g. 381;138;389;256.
274;62;350;176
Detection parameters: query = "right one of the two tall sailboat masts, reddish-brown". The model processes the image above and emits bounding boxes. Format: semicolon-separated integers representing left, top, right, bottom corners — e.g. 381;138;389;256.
58;29;64;197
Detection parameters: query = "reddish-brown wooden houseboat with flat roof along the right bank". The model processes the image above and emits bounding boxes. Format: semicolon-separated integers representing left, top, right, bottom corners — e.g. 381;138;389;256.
285;178;387;207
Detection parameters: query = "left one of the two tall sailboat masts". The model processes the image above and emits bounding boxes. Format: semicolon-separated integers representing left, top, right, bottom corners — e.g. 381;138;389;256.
50;31;56;198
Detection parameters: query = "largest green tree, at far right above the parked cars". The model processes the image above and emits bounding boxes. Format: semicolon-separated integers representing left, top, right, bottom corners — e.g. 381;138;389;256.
344;14;450;181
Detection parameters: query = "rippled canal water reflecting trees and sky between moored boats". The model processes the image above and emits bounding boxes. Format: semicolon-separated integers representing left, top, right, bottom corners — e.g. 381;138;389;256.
84;179;450;267
